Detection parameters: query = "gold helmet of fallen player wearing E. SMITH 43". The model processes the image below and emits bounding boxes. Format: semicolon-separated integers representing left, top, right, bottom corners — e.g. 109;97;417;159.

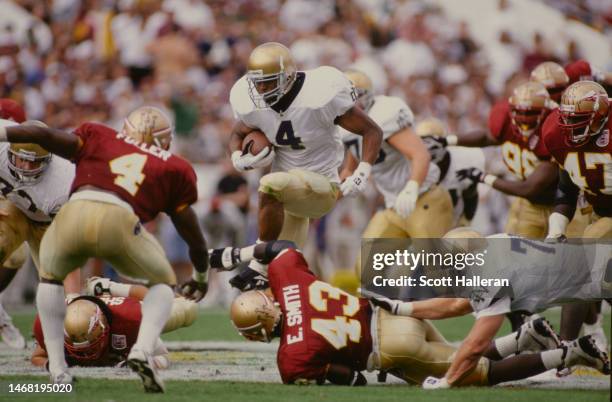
230;290;281;342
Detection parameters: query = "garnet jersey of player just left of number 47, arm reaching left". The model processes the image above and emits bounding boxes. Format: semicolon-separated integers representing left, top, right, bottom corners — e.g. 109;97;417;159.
489;101;550;180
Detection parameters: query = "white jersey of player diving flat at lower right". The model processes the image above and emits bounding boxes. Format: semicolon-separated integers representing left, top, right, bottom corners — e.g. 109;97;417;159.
469;235;612;316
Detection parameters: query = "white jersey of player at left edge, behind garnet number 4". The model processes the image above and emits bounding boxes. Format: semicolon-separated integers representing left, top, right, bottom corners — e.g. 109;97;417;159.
0;120;75;223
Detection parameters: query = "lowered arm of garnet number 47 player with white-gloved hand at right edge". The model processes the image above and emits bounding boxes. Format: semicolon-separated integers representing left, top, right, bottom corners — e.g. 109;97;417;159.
546;169;580;240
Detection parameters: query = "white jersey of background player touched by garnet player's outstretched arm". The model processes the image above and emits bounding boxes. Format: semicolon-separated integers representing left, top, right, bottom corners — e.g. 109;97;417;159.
440;146;485;225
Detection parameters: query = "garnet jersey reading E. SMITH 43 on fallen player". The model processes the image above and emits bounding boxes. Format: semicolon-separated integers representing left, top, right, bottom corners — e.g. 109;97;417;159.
268;249;372;384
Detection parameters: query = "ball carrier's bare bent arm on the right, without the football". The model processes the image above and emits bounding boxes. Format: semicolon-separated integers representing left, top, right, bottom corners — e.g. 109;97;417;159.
334;106;382;165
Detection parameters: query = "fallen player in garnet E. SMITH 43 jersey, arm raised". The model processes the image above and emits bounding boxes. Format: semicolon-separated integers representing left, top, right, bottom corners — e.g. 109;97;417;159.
210;240;607;385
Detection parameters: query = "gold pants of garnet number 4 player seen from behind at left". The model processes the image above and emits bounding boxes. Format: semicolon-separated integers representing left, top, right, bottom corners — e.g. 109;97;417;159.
40;199;176;285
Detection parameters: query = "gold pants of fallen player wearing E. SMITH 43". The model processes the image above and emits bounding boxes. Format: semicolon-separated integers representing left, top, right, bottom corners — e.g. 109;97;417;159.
372;308;489;385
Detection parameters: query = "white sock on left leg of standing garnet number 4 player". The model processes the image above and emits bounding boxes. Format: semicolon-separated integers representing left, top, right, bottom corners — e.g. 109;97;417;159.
36;282;68;373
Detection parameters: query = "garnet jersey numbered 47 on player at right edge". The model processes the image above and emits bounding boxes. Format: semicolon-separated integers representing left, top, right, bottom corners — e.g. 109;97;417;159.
542;109;612;212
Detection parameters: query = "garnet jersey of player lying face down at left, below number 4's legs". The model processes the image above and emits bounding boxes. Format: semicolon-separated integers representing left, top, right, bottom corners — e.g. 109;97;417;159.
33;297;142;366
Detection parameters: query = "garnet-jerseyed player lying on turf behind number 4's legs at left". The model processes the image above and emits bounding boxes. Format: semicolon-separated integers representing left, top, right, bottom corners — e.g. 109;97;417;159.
31;277;198;369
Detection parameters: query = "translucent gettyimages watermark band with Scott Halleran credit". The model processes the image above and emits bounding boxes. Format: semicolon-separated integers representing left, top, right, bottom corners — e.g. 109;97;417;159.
361;236;612;310
